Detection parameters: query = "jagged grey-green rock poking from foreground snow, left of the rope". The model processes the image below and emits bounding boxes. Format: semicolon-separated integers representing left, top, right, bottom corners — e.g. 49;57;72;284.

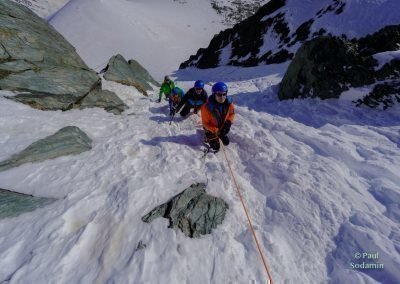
142;183;229;238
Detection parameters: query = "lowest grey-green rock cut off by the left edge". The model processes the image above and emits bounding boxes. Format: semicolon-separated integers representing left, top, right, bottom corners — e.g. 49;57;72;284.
0;188;55;219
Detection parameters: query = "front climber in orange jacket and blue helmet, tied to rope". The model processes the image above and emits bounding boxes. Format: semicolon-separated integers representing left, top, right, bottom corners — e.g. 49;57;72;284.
201;82;235;152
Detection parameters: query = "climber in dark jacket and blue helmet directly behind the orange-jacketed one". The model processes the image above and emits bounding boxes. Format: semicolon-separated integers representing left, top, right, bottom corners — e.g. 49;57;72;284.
176;80;208;116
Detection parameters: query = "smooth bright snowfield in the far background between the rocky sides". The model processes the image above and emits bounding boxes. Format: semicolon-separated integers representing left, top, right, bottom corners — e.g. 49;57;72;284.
46;0;223;79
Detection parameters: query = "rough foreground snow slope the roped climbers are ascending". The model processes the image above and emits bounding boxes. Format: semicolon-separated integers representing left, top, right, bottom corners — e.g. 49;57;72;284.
0;64;400;283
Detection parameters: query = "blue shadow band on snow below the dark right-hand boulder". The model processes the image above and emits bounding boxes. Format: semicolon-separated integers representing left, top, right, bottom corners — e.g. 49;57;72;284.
233;85;400;130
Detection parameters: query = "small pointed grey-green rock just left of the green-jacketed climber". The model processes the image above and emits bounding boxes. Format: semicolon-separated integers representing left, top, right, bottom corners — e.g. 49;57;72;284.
104;54;159;96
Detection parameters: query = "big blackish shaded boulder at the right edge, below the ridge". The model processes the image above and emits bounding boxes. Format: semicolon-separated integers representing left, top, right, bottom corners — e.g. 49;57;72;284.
278;25;400;108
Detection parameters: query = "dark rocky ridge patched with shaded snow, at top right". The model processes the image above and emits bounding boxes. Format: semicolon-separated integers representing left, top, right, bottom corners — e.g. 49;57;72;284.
181;0;400;68
